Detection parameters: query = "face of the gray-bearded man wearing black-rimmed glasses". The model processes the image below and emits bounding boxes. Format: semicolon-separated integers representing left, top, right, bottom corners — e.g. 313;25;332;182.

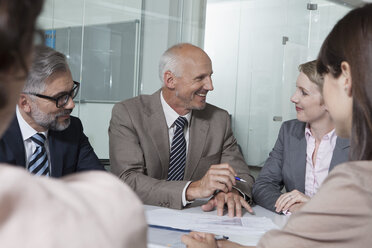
20;71;75;131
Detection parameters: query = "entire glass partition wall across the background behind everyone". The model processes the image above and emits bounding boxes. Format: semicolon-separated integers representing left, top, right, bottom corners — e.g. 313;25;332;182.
39;0;349;166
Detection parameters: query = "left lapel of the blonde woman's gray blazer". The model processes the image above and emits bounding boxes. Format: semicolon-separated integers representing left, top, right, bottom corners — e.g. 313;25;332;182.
290;122;307;193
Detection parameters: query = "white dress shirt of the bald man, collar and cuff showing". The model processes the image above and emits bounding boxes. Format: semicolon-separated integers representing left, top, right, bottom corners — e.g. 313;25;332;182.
160;91;192;206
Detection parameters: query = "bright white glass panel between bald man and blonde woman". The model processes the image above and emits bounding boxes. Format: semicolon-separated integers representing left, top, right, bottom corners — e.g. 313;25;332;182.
204;0;350;166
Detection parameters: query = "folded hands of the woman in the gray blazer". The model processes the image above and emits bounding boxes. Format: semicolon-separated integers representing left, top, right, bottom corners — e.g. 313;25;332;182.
275;189;310;213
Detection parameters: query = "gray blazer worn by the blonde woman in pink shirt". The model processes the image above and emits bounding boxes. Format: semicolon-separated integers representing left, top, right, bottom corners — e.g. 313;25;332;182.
252;120;350;211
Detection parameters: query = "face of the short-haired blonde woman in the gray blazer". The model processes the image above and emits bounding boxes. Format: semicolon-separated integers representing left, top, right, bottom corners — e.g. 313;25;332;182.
291;72;328;124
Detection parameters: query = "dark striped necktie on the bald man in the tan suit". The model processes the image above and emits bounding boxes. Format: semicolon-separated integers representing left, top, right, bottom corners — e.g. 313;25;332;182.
167;116;187;181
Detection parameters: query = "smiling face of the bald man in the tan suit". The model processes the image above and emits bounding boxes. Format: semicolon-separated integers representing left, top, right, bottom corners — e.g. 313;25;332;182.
163;46;213;115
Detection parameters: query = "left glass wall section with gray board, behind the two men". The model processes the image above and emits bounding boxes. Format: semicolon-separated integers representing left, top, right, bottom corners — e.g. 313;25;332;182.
38;0;206;159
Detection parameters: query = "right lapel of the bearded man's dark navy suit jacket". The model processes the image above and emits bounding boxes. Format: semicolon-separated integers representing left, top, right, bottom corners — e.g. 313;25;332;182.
48;130;65;177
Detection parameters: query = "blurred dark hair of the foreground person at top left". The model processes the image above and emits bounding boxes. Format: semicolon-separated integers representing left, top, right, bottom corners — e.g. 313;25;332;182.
0;0;44;74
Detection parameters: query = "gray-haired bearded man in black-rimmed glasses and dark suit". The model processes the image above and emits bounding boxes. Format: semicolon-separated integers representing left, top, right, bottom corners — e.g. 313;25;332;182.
0;45;104;177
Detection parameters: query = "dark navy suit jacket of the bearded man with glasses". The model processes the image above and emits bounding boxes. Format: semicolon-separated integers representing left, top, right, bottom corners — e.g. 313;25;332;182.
0;116;104;177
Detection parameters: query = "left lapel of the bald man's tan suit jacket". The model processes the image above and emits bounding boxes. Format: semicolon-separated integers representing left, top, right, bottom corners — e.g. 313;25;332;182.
146;90;170;178
